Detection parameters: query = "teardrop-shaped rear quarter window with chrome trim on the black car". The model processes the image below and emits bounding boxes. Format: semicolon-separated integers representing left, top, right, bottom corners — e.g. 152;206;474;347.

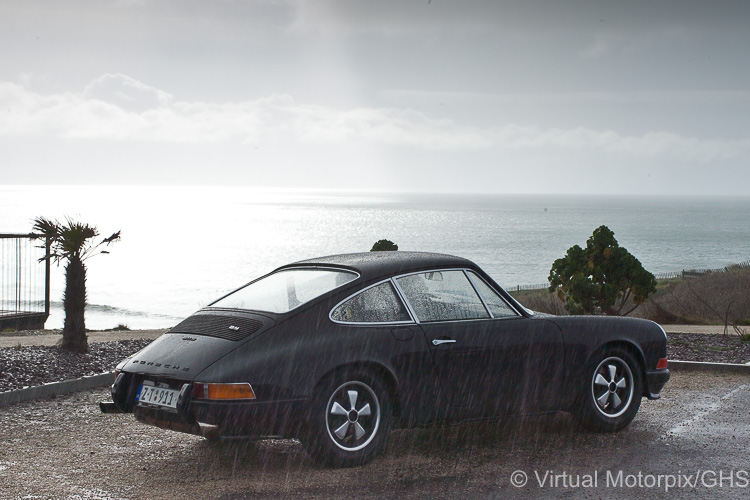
331;281;411;323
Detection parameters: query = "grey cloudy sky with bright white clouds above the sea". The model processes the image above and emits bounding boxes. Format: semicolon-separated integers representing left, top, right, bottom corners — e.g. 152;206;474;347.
0;0;750;196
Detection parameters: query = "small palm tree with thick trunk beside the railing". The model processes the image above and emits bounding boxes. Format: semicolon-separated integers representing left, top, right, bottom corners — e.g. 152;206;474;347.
34;217;120;352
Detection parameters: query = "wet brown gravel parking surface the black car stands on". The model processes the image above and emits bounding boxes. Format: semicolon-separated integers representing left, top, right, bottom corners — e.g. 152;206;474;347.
0;372;750;500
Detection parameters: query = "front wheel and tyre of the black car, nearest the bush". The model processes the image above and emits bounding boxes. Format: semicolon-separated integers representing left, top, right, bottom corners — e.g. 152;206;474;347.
575;348;643;432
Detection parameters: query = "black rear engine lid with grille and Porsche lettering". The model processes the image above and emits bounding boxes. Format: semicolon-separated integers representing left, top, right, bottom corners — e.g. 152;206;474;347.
117;308;276;380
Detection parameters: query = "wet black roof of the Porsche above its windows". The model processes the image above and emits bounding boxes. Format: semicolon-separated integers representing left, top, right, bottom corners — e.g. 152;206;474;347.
279;251;476;281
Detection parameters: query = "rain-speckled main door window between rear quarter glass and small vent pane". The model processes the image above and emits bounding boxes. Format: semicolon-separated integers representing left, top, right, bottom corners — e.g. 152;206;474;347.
396;271;490;322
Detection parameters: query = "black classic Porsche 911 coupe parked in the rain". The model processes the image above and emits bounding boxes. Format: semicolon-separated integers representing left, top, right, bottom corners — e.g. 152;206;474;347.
101;252;669;466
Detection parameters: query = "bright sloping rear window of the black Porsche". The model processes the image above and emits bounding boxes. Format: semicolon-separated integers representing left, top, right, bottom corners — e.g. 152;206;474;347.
210;268;357;313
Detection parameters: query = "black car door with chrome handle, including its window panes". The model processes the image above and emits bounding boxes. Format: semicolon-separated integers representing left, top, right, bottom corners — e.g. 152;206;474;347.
396;270;563;416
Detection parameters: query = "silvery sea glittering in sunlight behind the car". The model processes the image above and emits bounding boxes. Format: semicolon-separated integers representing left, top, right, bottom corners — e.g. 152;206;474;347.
0;186;750;329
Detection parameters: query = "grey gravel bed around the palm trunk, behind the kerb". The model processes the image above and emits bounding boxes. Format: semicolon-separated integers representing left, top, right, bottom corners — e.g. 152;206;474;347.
0;339;151;392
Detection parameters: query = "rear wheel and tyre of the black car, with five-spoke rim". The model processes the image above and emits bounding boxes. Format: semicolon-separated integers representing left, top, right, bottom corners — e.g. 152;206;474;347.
301;373;393;467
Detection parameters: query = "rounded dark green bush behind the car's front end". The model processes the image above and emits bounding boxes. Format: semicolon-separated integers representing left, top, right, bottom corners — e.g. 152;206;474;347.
549;226;656;316
